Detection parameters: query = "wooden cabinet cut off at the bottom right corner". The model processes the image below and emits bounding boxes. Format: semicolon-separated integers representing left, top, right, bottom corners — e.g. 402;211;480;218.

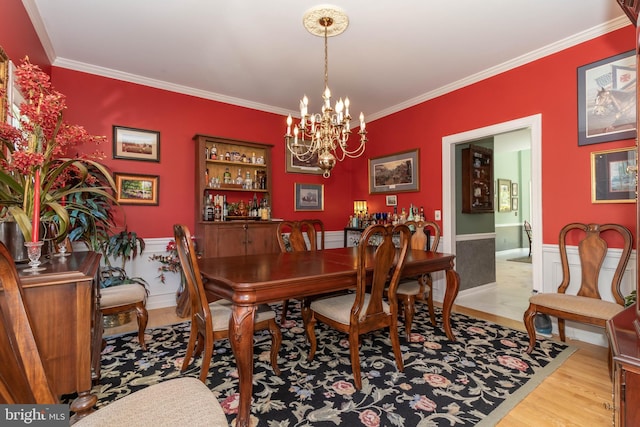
607;306;640;427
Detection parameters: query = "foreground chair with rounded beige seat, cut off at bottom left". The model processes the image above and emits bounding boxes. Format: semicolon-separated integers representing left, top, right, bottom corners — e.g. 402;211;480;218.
0;243;228;427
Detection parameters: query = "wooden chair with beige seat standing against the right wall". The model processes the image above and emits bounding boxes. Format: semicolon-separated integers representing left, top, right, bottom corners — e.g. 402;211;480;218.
524;223;632;353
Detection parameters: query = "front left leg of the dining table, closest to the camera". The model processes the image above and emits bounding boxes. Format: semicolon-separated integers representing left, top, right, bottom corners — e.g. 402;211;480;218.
229;304;256;427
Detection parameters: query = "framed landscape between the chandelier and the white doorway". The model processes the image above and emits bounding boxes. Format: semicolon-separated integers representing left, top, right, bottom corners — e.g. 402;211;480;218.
369;149;420;194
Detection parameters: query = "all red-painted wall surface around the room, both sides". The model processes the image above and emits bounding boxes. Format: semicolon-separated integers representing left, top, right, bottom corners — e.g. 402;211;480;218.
0;1;635;243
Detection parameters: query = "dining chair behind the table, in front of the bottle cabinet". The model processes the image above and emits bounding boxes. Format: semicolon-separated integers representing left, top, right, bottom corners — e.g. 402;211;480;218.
276;220;324;325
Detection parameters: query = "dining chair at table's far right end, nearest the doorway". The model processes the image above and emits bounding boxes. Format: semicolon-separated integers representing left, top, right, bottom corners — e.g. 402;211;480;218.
396;221;440;341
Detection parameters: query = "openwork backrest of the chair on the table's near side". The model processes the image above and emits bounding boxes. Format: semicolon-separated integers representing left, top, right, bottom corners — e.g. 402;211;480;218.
351;224;411;324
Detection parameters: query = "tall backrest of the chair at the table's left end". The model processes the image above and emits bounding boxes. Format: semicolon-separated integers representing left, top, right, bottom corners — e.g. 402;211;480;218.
173;224;213;330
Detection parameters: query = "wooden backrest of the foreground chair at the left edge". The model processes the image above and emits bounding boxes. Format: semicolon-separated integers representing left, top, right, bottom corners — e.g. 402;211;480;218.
0;243;58;404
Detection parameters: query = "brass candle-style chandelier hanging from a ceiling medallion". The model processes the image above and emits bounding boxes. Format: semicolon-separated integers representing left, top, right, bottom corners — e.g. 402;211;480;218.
285;5;367;178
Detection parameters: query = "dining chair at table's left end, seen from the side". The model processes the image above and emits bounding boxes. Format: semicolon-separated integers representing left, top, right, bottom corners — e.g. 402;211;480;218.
173;224;282;383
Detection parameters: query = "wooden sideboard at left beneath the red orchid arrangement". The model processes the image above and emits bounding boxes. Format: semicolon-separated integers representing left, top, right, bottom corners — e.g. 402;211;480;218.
18;252;102;413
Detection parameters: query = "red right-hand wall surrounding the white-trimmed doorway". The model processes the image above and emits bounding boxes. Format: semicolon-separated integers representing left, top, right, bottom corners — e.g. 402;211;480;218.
354;25;636;247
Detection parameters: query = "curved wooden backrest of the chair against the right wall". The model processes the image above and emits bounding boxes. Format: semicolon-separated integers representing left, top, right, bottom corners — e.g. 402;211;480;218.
558;223;632;305
